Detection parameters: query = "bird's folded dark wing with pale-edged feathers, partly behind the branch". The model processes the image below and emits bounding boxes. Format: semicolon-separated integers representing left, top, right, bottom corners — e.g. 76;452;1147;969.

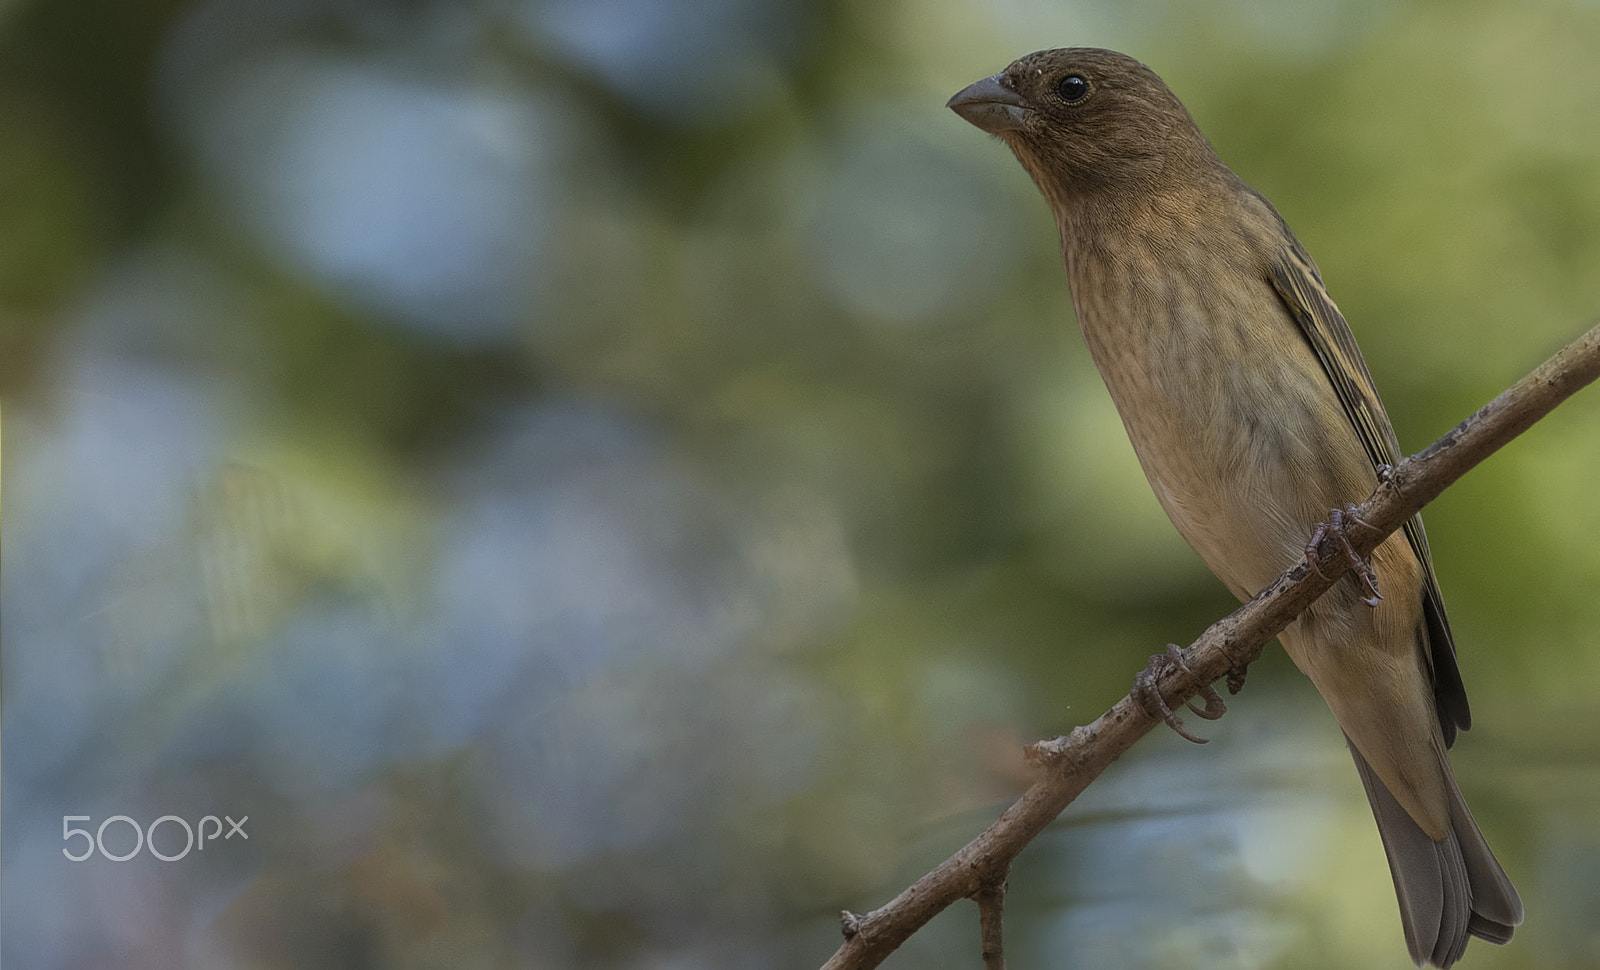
1272;242;1472;748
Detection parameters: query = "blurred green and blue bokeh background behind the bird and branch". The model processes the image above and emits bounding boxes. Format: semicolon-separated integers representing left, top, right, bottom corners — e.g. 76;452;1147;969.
0;0;1600;970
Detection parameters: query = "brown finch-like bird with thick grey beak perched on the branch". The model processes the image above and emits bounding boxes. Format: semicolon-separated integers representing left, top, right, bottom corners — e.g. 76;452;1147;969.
949;48;1522;967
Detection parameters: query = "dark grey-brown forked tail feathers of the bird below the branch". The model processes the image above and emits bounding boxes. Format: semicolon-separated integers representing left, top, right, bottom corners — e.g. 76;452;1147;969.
1346;736;1522;967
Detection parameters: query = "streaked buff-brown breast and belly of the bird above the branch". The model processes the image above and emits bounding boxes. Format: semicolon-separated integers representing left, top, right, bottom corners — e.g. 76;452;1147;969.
1069;241;1376;599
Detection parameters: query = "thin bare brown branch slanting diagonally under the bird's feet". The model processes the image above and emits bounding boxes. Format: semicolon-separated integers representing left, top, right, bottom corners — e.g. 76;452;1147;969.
822;325;1600;970
